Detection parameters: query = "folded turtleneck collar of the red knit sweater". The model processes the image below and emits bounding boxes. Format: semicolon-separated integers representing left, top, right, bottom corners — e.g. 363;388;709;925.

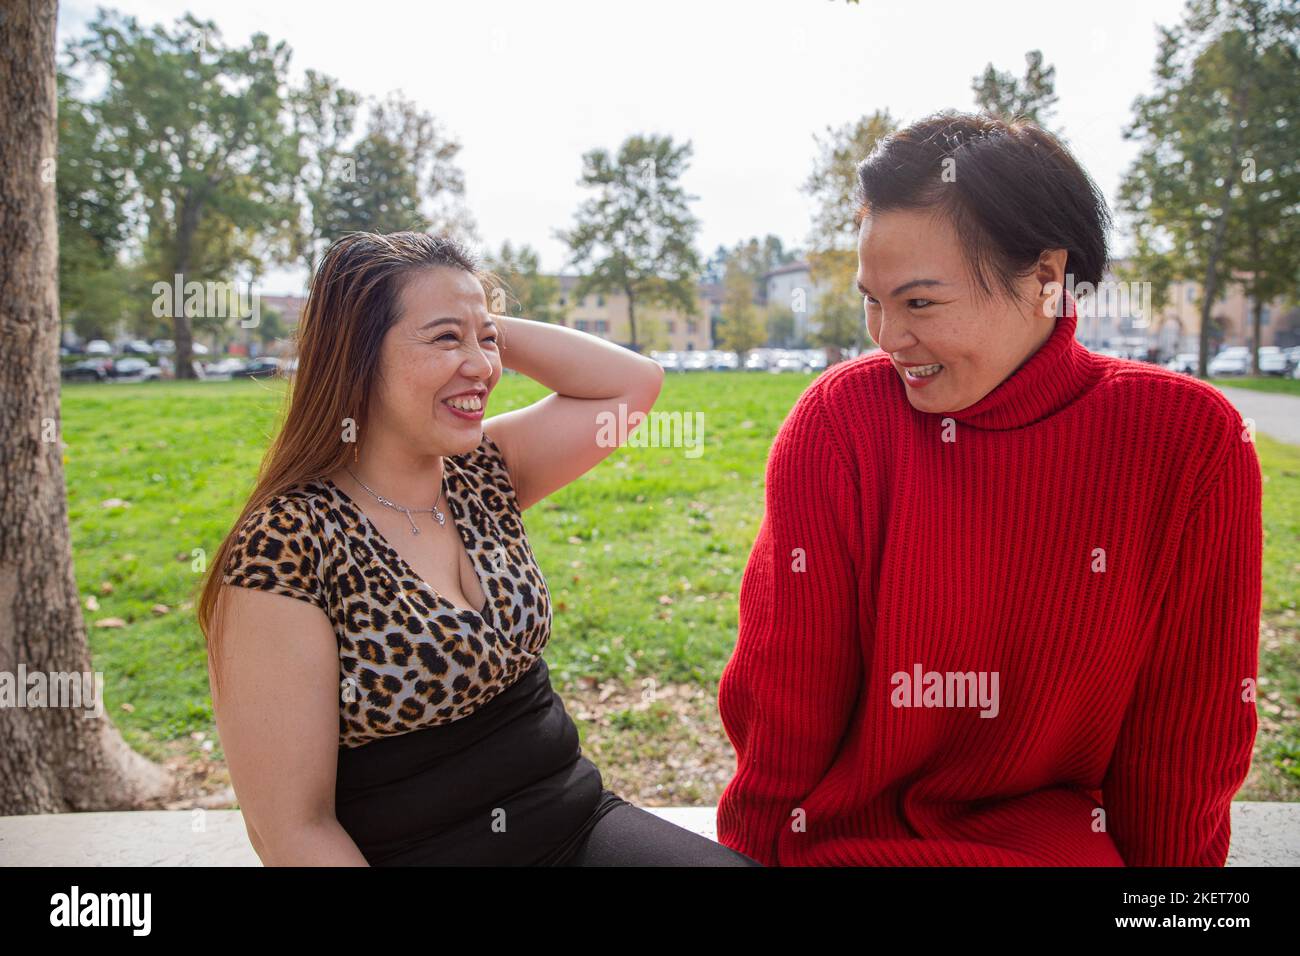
943;293;1104;431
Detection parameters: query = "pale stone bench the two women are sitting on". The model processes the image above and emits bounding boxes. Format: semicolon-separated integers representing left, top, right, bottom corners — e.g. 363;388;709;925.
0;801;1300;866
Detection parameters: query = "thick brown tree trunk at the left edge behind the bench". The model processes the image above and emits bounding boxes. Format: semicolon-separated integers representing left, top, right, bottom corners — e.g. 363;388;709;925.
0;0;169;814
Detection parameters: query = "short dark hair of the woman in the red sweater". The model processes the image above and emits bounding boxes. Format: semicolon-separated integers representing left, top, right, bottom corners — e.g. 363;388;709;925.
857;111;1110;306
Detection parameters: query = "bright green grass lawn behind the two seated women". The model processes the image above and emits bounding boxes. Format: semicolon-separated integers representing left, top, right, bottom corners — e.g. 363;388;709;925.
62;373;1300;799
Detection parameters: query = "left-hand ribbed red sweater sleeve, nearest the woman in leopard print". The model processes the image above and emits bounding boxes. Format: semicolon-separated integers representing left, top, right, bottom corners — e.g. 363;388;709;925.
718;388;862;866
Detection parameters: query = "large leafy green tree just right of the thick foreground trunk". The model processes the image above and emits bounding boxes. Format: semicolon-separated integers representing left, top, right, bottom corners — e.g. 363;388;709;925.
69;10;300;377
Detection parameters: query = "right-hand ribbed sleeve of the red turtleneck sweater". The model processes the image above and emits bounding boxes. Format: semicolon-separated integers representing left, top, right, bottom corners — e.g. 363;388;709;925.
1102;428;1264;866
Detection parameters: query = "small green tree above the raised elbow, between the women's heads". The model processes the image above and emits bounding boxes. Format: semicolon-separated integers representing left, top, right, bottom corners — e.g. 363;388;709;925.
559;135;701;349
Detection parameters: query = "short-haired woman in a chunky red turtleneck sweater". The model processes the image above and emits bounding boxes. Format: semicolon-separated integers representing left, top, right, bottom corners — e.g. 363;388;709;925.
718;113;1262;866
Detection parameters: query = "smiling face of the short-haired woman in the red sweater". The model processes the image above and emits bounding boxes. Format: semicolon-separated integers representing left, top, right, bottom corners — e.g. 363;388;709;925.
858;209;1066;412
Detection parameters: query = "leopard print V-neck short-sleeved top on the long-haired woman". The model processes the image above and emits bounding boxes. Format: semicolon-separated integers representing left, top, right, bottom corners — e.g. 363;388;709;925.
222;433;551;748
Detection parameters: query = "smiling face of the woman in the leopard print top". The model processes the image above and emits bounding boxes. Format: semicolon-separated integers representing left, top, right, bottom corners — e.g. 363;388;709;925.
371;265;501;455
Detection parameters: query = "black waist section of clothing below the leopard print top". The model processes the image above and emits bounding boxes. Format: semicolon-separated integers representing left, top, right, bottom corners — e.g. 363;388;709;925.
334;658;625;866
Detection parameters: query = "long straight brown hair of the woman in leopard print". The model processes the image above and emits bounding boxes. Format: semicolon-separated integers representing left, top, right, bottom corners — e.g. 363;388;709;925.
198;233;498;697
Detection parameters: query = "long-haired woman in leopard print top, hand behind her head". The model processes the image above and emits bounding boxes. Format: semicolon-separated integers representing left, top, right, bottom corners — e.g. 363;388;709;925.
199;233;757;866
